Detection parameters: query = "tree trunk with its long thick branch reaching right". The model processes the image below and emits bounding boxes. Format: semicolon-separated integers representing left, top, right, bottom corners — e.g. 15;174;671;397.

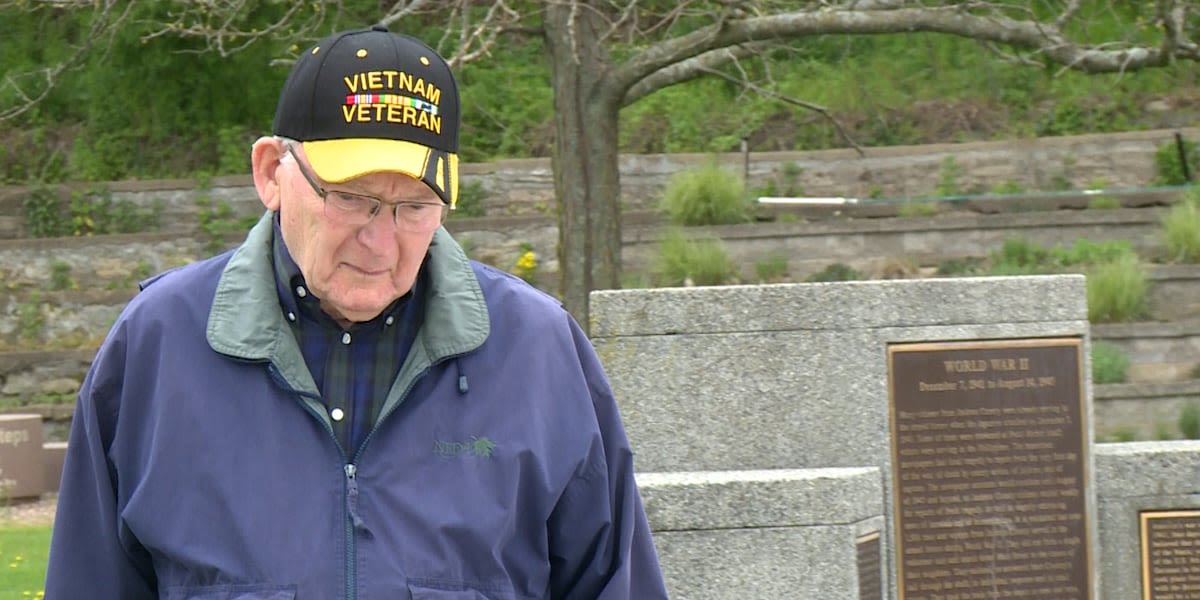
508;0;1200;324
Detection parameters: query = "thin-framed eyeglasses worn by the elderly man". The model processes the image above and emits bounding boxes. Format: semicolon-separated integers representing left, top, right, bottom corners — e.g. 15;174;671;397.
287;144;450;233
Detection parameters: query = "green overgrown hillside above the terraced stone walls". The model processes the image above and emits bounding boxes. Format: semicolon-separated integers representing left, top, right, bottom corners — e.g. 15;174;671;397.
0;2;1200;184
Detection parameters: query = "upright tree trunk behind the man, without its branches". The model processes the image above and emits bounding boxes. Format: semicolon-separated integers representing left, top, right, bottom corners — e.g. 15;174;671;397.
544;2;625;330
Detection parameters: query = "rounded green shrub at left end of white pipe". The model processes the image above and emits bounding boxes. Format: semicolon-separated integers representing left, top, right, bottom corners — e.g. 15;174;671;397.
662;160;751;226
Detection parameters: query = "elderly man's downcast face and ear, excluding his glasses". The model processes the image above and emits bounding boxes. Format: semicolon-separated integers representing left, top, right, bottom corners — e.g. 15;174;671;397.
277;143;442;325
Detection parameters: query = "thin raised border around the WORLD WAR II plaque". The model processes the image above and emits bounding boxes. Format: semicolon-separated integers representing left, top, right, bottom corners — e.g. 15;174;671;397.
887;336;1094;600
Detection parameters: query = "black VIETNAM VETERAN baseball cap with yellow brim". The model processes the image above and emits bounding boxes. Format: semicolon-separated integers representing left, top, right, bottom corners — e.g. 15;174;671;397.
272;25;460;208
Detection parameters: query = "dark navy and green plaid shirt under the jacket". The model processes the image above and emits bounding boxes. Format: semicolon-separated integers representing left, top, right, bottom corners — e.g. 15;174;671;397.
272;220;425;458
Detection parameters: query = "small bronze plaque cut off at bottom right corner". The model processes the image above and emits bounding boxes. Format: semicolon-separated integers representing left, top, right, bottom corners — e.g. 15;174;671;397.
1140;510;1200;600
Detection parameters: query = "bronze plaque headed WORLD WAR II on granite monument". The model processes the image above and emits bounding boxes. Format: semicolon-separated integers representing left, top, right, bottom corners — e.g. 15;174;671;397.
888;338;1092;600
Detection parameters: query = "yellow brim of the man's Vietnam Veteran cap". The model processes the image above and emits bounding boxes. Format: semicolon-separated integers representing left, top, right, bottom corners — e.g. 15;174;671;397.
301;138;458;209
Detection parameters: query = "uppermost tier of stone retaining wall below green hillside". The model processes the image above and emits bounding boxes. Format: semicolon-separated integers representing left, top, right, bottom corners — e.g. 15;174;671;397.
0;127;1200;238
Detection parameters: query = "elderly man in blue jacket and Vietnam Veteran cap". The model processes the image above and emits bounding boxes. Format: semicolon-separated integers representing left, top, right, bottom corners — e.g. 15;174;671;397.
46;28;666;600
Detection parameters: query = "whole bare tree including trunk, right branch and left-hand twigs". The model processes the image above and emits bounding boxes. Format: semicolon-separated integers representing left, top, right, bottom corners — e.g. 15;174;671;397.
0;0;1200;326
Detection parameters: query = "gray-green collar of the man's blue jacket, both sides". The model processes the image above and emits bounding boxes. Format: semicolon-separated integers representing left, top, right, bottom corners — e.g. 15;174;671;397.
206;212;491;396
